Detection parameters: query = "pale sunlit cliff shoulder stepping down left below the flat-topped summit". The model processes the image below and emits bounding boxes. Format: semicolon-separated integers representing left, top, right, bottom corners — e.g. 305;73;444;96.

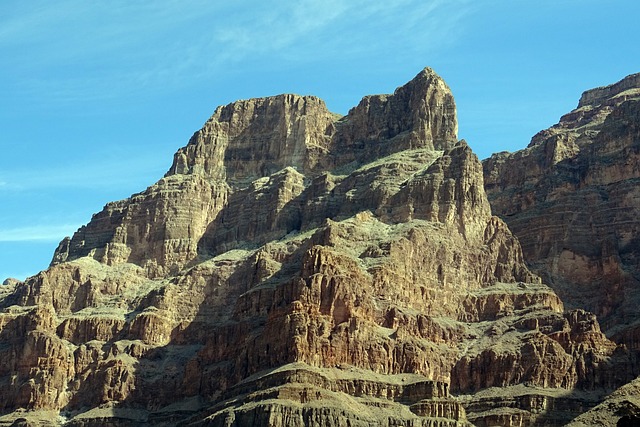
52;175;228;277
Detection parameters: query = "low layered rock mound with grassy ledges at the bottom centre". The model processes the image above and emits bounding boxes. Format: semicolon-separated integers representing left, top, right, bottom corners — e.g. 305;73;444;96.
185;363;469;426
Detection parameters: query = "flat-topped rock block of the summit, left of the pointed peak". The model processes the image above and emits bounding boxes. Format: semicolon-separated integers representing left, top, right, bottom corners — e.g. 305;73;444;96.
167;95;336;186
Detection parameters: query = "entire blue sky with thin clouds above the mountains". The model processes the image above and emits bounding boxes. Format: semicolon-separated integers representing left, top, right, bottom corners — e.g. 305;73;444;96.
0;0;640;281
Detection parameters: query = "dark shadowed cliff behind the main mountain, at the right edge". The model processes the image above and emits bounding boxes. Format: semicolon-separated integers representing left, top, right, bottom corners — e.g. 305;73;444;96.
484;74;640;344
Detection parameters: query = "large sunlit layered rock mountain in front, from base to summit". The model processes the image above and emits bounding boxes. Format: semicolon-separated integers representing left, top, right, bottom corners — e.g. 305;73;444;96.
0;69;635;426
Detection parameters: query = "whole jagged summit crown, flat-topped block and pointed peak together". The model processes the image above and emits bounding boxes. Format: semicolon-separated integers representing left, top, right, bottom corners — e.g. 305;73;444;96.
167;68;457;186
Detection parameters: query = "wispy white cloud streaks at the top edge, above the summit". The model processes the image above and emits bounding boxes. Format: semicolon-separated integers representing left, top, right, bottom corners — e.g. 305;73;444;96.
208;0;472;61
